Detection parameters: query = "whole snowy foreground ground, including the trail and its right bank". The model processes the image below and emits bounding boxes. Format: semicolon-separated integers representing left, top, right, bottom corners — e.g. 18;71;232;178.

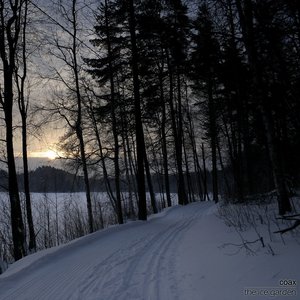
0;202;300;300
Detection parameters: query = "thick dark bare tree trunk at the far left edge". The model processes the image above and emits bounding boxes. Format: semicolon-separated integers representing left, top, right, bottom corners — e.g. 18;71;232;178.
0;0;26;260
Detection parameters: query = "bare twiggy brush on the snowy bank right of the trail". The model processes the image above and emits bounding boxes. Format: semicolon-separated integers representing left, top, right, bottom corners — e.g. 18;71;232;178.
218;193;300;255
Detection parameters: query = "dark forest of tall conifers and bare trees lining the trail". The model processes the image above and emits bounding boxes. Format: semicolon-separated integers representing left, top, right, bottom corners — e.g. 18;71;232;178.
0;0;300;260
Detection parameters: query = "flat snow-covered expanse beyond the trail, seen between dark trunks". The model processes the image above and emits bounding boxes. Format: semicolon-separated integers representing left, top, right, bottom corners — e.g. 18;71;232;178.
0;192;178;260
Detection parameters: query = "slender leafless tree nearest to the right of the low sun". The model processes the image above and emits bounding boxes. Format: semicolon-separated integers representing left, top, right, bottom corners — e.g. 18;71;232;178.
40;0;94;232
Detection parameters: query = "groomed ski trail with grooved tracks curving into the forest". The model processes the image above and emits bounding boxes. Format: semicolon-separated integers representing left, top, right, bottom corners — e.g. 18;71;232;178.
0;203;213;300
